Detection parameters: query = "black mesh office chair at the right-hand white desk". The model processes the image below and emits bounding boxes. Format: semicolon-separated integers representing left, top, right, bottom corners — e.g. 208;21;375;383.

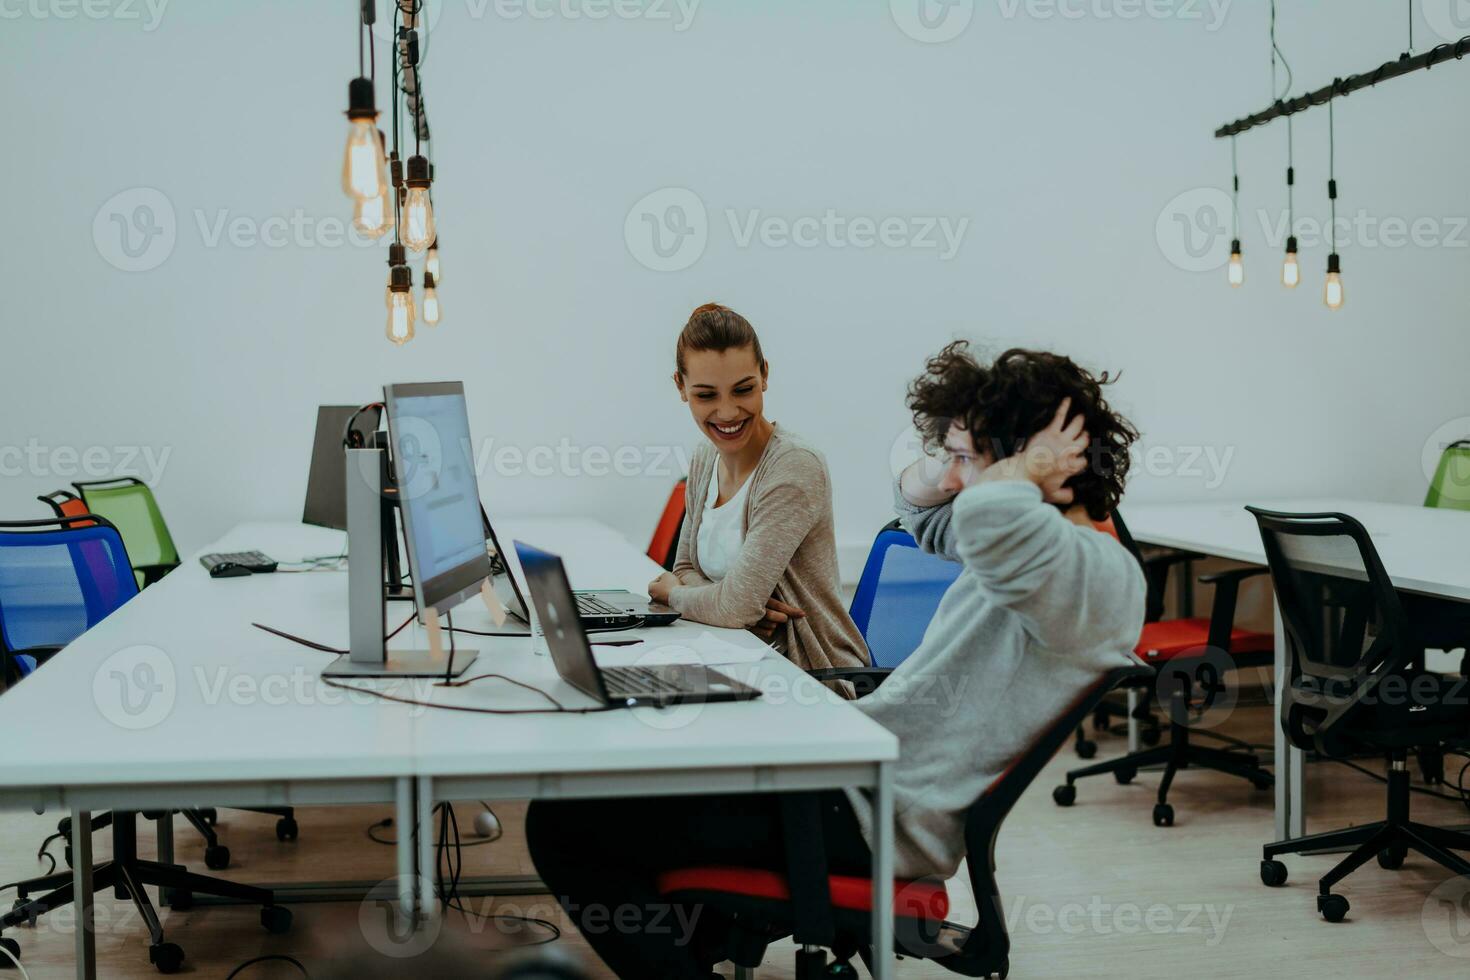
1247;507;1470;923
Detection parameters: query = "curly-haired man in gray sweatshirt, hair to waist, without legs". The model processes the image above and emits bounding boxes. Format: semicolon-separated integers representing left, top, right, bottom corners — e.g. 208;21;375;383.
848;341;1144;877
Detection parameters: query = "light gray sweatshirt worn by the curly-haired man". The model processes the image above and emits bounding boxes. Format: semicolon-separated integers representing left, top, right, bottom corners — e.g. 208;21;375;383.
848;480;1144;879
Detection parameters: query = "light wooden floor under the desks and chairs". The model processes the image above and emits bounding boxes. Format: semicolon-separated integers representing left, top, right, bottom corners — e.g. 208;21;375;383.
0;708;1470;980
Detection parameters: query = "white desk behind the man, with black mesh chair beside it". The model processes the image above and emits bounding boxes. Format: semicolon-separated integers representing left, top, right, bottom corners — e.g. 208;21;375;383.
1123;497;1470;840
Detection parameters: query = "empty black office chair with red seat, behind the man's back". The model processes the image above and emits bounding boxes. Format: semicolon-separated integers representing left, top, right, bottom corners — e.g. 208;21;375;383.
1051;514;1276;827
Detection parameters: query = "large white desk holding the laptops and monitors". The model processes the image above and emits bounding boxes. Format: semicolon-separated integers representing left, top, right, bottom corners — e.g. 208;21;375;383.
0;520;898;977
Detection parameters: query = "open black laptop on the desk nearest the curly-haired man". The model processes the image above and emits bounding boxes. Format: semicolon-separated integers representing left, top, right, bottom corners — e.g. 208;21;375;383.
516;541;760;708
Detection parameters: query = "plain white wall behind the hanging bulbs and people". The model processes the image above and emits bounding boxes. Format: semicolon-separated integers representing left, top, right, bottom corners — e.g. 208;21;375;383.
0;0;1470;575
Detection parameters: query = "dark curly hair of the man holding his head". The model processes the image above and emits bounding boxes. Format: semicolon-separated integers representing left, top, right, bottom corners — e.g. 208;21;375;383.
908;341;1138;520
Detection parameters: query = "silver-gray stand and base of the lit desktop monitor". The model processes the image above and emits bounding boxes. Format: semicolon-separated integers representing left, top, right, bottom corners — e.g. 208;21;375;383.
322;448;479;677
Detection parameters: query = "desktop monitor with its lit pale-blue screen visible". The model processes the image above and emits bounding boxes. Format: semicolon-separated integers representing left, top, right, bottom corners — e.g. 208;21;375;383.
384;382;490;619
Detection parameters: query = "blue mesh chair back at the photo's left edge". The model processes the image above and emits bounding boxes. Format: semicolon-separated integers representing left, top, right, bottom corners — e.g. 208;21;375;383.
0;517;138;674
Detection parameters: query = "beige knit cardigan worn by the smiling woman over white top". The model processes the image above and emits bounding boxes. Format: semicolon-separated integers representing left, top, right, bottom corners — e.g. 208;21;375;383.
669;428;869;670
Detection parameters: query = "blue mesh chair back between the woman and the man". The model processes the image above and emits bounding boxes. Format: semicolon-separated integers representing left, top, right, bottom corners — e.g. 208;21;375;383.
848;522;964;669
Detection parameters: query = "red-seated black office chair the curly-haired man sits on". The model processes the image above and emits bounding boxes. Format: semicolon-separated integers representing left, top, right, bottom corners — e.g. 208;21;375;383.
659;666;1152;980
